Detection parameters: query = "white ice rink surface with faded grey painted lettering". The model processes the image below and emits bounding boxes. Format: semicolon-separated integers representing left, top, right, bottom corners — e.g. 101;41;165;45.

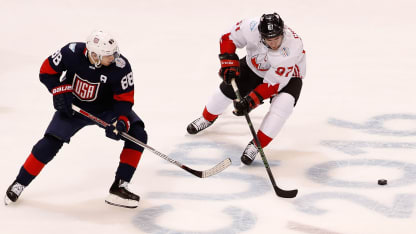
0;0;416;234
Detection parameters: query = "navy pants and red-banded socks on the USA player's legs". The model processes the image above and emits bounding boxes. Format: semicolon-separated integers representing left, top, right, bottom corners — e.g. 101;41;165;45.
16;111;147;186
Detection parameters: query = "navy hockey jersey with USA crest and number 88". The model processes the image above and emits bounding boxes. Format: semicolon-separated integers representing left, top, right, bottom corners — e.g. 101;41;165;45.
39;42;134;116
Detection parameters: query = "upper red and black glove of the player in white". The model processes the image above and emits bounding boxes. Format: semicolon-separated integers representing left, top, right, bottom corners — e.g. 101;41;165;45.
218;53;240;84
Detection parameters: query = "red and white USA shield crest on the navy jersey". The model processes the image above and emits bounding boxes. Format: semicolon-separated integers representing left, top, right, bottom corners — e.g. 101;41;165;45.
72;74;100;102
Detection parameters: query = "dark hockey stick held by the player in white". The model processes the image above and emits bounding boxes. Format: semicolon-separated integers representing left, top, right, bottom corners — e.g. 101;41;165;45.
231;79;298;198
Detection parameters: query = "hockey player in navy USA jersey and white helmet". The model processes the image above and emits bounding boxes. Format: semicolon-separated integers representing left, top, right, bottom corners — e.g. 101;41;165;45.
4;31;147;208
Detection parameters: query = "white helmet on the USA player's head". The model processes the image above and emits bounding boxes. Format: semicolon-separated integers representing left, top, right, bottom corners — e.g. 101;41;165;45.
86;30;120;67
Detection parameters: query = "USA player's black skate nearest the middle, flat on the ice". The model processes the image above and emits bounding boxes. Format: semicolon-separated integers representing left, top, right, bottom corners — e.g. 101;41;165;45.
105;179;140;208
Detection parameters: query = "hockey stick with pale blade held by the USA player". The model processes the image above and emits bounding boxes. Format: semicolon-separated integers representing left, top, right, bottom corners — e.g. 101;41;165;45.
72;104;231;178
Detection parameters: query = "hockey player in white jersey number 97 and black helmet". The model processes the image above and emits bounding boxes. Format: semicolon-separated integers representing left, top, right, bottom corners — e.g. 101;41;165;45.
187;13;306;165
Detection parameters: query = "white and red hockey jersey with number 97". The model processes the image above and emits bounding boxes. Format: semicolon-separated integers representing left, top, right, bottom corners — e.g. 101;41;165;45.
229;18;306;90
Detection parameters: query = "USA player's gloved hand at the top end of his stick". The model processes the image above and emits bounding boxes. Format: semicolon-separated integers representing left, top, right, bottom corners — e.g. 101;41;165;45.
52;84;74;117
